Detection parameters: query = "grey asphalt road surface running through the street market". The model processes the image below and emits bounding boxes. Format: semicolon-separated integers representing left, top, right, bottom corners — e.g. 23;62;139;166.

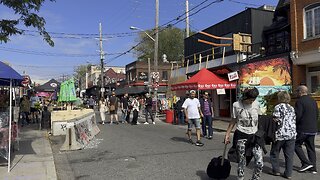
51;113;320;180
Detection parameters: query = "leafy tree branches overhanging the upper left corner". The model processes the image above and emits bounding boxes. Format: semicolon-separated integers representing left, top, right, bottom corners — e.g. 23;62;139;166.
0;0;55;46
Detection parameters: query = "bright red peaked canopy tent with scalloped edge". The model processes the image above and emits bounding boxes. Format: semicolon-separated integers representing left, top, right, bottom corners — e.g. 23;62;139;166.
171;69;237;91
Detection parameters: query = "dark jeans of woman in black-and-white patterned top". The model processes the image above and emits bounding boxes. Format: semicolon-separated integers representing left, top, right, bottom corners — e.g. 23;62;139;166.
270;139;296;177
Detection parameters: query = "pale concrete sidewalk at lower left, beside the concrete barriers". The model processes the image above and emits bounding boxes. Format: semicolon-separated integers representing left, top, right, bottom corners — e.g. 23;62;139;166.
0;125;57;180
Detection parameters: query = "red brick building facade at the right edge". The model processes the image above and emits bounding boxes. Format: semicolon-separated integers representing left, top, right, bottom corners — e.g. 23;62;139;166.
290;0;320;93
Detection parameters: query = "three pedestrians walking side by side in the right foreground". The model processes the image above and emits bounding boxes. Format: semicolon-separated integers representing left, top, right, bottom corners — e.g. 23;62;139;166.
224;85;318;180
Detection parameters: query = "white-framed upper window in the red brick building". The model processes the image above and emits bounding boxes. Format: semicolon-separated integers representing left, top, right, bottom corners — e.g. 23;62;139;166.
304;3;320;39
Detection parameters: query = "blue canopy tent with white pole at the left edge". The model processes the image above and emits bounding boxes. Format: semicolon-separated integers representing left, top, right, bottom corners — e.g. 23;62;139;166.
0;61;23;172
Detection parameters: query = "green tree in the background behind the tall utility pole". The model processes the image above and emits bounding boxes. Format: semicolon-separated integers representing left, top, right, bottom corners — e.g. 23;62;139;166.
135;27;184;61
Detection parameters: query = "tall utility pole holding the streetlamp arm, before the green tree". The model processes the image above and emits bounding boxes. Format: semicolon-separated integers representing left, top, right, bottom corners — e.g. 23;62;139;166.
154;0;159;118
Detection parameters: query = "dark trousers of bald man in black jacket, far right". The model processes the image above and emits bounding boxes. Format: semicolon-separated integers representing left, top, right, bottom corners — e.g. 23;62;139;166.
295;133;317;170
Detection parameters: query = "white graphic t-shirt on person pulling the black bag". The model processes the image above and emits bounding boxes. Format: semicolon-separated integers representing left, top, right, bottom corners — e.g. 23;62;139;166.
233;100;261;134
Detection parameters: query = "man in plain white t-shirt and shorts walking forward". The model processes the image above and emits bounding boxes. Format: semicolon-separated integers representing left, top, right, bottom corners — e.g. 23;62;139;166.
182;90;203;146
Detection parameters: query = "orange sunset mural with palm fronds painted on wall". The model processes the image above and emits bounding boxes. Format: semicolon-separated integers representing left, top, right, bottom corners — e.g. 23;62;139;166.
239;57;292;113
